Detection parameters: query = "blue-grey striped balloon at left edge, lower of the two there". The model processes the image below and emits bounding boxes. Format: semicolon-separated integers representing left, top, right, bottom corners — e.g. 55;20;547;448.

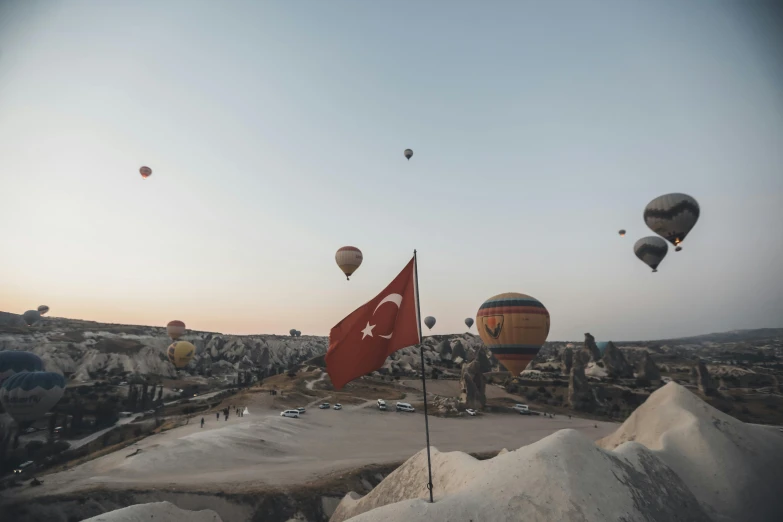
0;372;65;422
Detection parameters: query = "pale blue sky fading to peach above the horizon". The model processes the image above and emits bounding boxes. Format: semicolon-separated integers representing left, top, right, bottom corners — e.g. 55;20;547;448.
0;0;783;340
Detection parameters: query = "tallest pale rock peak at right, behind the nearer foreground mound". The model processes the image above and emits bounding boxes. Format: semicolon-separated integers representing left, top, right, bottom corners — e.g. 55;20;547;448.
598;383;783;521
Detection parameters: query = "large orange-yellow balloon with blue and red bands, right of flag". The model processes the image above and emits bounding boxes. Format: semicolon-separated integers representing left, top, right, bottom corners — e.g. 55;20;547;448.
476;292;549;376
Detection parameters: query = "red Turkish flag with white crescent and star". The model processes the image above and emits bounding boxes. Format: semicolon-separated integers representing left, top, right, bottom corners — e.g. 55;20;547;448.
326;259;419;390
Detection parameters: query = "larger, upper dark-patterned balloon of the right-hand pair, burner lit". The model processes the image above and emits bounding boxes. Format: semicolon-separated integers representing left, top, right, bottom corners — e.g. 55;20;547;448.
644;193;700;252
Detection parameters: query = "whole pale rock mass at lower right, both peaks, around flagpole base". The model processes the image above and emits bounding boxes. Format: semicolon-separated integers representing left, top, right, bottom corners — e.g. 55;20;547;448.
332;383;783;522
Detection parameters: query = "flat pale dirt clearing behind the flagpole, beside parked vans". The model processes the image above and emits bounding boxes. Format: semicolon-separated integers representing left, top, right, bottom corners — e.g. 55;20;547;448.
4;381;617;499
